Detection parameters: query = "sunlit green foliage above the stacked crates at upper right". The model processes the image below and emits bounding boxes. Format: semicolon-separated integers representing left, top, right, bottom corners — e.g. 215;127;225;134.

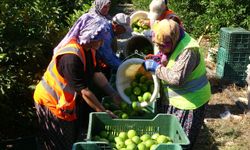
169;0;250;44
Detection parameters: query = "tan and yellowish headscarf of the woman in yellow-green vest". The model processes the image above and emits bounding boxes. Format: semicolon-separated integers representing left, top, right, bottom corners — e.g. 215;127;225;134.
153;19;184;51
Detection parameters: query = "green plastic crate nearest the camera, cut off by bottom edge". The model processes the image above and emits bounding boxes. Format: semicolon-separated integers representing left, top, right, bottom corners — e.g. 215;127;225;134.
72;142;182;150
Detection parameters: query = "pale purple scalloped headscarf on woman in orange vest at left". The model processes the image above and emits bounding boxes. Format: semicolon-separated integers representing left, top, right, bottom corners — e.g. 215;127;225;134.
54;13;110;53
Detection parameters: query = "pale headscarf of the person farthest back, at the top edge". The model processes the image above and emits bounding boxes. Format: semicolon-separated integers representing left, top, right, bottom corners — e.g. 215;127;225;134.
89;0;111;19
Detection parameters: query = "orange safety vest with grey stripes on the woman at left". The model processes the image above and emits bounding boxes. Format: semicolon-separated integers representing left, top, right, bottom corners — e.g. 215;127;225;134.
34;38;96;121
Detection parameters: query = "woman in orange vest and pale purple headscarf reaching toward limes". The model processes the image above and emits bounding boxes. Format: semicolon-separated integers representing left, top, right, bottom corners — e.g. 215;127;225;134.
34;13;121;150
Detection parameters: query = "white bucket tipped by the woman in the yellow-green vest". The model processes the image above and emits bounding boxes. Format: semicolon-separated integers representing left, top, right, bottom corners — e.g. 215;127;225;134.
116;58;160;107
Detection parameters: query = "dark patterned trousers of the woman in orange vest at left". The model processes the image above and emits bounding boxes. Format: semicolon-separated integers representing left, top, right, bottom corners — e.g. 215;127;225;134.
35;99;93;150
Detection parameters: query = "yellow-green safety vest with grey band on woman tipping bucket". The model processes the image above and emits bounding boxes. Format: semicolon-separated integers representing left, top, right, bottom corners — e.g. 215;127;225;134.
162;33;211;110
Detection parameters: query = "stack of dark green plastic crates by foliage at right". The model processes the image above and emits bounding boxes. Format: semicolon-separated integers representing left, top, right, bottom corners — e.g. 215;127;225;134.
216;28;250;85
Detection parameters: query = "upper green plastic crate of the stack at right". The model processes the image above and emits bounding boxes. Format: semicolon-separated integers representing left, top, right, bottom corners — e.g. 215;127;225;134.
219;27;250;51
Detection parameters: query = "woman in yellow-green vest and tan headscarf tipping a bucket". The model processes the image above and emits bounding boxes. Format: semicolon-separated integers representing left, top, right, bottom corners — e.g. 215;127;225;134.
144;19;211;149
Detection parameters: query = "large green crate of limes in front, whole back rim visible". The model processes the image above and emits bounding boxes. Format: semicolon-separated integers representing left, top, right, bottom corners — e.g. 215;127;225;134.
87;112;189;145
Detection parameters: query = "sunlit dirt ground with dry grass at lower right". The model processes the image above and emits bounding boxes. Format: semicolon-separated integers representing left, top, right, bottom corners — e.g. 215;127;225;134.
194;37;250;150
